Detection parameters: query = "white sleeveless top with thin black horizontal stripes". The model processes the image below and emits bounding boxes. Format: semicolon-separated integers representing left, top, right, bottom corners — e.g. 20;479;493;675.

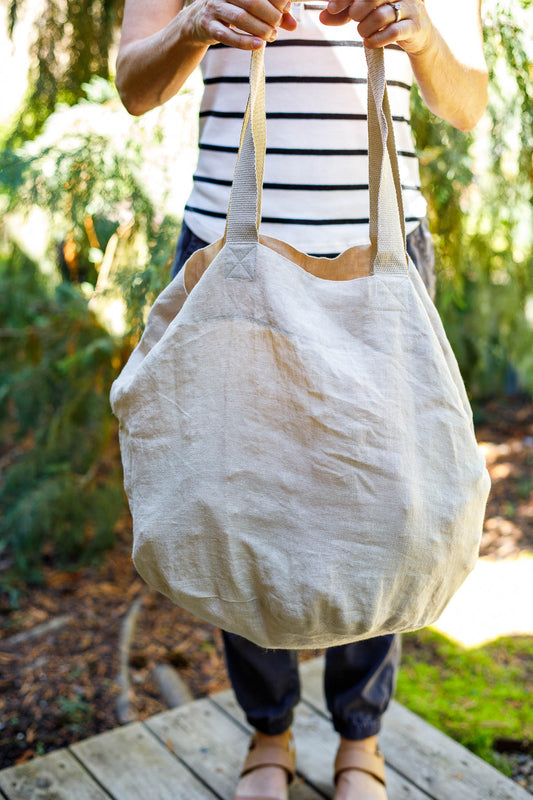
185;3;426;255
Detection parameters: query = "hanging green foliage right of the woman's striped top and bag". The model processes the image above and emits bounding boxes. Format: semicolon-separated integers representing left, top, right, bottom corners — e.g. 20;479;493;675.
414;0;533;399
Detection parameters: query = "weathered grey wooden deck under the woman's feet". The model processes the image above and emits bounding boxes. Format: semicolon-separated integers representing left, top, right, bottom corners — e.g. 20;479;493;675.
0;659;531;800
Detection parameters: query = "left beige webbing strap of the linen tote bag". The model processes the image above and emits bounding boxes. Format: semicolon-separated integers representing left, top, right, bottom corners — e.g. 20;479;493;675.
225;46;266;242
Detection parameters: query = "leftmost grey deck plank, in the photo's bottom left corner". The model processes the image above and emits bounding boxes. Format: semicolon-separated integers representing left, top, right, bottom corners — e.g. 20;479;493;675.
0;750;109;800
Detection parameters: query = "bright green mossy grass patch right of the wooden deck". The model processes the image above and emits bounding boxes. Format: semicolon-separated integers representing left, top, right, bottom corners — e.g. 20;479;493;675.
396;628;533;774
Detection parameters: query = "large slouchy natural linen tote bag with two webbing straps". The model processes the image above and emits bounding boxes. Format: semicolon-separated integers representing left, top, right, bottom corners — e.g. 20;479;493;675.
111;45;489;648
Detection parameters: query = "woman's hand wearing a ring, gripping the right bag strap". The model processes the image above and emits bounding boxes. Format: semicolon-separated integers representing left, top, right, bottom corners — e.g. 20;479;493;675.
320;0;432;54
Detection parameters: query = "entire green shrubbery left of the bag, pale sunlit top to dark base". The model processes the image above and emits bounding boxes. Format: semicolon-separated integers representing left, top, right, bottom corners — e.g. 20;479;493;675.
0;82;178;583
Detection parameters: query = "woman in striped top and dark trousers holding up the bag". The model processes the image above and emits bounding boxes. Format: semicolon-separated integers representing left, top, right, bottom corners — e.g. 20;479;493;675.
117;0;487;800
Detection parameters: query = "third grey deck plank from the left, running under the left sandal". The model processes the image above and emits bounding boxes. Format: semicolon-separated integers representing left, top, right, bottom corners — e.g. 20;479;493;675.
145;699;321;800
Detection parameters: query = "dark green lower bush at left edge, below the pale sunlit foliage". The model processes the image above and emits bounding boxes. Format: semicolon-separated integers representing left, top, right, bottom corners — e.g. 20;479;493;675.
0;246;124;579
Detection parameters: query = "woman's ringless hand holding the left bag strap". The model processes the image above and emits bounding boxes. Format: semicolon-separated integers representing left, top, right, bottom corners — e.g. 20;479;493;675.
181;0;297;50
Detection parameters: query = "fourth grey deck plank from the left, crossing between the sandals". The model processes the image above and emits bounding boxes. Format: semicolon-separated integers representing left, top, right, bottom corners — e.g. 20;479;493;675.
211;691;428;800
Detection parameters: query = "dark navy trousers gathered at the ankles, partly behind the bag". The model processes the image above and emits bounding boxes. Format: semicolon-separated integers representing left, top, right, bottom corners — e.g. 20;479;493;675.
172;220;435;739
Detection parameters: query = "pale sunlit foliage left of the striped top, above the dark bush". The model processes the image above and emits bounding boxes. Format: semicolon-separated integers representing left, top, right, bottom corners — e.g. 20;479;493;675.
0;86;179;336
